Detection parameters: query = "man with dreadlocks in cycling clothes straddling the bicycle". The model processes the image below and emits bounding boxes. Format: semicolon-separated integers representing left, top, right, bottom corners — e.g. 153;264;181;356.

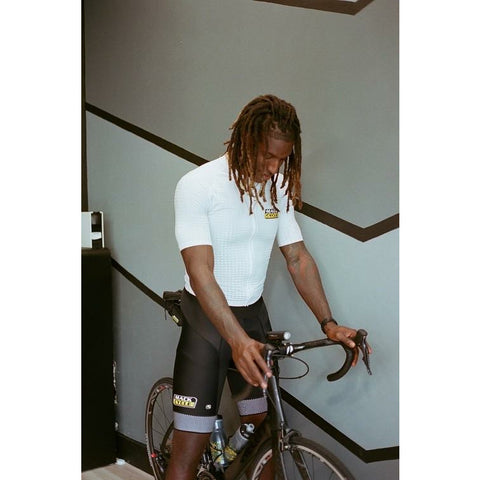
166;95;368;480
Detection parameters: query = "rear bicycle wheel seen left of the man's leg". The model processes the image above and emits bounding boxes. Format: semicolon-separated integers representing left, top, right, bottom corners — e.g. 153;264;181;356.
145;377;173;480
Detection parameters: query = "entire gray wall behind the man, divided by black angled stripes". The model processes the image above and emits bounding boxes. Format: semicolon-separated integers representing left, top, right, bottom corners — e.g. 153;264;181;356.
85;0;398;479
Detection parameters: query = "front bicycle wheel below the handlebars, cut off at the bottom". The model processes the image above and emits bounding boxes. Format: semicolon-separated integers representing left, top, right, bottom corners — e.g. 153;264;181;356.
248;436;355;480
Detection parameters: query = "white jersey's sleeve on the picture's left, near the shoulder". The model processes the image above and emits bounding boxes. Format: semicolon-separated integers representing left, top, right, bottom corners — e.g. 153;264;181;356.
174;169;212;250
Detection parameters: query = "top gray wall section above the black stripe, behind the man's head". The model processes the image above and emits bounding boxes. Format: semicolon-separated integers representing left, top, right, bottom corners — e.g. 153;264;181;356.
85;0;398;226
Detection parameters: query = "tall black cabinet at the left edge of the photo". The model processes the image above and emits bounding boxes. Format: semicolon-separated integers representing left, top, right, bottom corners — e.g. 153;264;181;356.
82;248;116;471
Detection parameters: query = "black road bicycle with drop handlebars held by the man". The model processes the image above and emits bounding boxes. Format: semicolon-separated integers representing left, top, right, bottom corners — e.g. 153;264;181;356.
145;292;372;480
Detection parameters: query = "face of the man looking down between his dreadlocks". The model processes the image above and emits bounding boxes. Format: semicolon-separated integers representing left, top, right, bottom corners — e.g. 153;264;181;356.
255;135;293;183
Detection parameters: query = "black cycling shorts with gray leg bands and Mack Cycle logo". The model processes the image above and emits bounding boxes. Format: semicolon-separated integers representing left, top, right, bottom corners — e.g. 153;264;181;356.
173;289;271;433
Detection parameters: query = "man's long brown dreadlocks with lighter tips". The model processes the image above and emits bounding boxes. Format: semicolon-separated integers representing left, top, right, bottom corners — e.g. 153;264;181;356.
225;95;302;214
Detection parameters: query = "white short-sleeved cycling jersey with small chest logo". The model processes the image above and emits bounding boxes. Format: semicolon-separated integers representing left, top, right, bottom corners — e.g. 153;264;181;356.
175;155;303;306
